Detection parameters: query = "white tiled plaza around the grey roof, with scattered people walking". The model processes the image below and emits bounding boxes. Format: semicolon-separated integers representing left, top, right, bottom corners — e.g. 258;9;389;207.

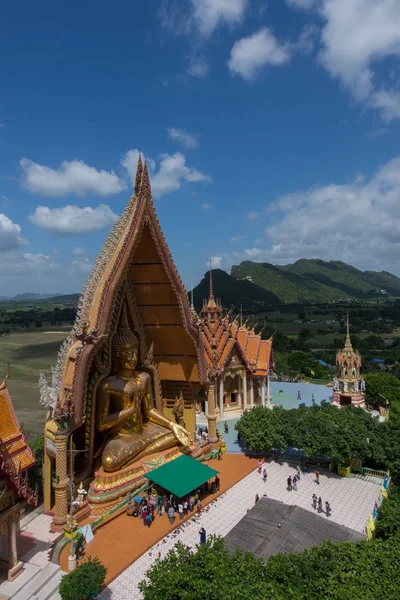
97;463;382;600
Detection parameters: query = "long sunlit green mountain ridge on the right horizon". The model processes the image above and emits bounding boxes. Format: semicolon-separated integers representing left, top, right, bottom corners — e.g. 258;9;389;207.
230;259;400;303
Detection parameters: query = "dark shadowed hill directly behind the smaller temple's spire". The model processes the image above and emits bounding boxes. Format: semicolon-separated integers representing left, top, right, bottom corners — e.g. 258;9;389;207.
189;269;280;311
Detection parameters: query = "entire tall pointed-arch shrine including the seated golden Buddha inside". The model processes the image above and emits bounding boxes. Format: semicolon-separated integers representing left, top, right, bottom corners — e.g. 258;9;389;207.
41;156;207;527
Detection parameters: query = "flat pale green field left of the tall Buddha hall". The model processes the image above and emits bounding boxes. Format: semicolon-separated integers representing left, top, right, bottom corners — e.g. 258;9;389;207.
0;330;67;439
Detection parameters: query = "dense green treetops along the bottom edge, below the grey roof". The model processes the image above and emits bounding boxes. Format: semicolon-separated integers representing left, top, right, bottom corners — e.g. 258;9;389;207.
139;535;400;600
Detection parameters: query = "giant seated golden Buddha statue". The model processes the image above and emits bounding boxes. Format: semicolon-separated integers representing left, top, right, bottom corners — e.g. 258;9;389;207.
96;307;192;472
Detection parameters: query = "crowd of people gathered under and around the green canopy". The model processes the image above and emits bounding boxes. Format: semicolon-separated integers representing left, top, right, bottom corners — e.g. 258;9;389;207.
127;475;220;527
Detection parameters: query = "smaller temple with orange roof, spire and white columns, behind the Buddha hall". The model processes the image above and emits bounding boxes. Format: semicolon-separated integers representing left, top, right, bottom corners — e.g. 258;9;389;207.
196;268;274;419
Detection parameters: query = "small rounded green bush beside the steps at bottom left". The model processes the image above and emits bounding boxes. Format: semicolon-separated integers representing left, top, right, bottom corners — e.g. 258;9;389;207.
59;556;107;600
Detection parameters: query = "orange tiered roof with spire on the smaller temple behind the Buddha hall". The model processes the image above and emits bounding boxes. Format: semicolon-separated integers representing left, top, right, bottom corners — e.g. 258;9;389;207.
197;268;273;377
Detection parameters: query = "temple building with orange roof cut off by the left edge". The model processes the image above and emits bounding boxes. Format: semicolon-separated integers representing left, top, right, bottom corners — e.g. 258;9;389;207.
0;368;37;581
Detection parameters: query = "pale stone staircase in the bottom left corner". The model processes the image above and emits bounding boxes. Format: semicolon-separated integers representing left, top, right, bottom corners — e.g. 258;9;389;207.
0;563;65;600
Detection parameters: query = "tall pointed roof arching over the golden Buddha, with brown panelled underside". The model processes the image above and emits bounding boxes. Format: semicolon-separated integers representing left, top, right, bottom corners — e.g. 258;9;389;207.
48;156;207;427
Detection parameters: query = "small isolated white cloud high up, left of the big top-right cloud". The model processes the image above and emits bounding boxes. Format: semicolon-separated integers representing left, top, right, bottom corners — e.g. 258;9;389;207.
227;27;290;81
